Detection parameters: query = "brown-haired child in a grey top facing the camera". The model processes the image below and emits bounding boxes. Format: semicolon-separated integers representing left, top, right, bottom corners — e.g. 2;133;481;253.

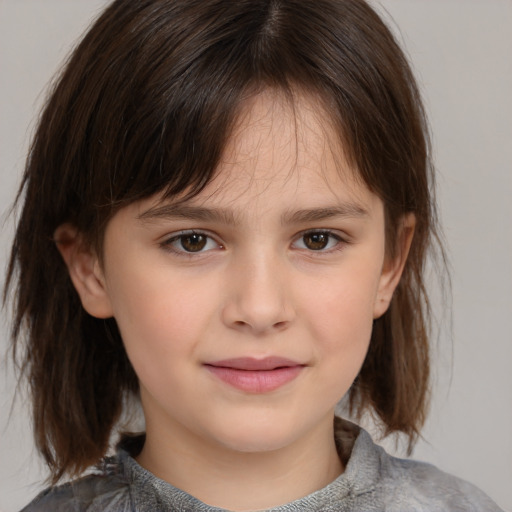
8;0;504;511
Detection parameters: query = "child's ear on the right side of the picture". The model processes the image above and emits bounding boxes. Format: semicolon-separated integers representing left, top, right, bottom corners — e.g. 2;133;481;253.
373;213;416;319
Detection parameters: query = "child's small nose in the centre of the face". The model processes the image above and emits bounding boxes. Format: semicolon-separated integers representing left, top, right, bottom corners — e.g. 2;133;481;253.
222;252;295;335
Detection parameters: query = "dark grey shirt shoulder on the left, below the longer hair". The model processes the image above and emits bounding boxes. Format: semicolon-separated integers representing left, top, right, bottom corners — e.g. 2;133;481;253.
21;461;132;512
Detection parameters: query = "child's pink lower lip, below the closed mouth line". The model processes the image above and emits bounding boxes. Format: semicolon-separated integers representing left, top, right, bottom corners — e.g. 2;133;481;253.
206;365;304;393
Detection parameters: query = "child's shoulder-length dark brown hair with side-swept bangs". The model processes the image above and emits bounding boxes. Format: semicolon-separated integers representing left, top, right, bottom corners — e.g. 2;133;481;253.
4;0;438;482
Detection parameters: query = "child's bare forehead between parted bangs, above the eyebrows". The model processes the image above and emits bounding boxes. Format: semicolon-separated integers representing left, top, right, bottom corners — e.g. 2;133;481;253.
188;90;369;208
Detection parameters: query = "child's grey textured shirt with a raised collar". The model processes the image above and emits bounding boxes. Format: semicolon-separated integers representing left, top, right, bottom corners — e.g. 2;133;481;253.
22;421;503;512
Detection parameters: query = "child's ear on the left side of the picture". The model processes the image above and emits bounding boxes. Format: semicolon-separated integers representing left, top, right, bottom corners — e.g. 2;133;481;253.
53;224;113;318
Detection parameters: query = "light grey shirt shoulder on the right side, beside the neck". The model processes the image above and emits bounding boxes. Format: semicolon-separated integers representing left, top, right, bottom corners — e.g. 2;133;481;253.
338;420;502;512
